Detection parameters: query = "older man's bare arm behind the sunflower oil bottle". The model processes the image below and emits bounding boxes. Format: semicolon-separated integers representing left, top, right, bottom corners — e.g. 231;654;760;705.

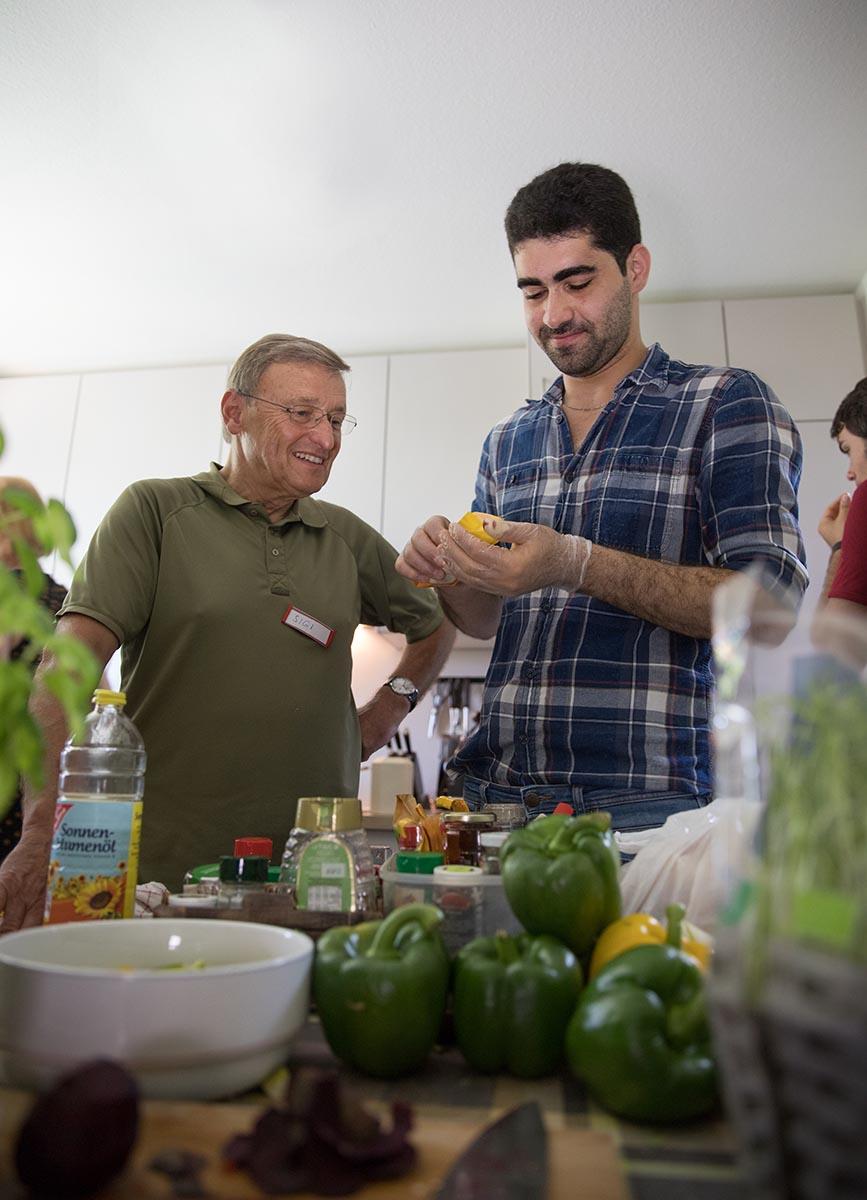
0;613;118;934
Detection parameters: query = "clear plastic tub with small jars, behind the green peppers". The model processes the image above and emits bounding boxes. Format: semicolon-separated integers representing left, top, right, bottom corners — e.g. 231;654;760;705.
379;856;524;954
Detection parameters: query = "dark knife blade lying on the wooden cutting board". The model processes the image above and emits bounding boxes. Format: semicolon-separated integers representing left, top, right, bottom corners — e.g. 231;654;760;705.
434;1100;548;1200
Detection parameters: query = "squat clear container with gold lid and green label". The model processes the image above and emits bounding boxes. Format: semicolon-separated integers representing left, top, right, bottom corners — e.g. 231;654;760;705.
280;796;377;912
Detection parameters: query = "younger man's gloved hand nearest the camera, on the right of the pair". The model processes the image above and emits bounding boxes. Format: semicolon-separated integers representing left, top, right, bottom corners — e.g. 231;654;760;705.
437;517;592;596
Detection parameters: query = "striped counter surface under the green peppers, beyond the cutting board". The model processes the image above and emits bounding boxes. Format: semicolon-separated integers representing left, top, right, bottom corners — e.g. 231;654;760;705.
291;1018;746;1200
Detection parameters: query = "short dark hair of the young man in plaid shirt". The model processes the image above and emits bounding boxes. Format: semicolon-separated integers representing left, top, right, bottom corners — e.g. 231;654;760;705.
506;162;641;274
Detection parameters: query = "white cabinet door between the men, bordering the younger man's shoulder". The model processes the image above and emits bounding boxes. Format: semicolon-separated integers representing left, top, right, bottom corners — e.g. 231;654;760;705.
381;347;527;550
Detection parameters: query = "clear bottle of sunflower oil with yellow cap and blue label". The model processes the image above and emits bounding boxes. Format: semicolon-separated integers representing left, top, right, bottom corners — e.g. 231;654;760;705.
44;688;147;924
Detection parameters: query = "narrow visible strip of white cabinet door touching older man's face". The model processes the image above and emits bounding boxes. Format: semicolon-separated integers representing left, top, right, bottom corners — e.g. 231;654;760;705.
317;354;388;530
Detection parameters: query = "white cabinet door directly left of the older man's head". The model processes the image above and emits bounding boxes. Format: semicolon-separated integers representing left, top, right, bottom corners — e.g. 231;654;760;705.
62;366;227;582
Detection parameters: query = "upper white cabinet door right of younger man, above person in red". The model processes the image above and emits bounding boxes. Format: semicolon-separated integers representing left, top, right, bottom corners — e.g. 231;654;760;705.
724;295;865;421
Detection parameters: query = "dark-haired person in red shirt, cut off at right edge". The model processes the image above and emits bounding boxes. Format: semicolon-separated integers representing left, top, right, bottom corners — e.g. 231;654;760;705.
818;378;867;658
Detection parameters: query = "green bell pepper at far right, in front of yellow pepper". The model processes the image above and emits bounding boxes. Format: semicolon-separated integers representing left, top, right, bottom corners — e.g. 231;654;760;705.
566;910;717;1121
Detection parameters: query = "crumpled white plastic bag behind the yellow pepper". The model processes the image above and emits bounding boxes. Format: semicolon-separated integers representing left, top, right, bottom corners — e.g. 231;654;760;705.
615;798;760;934
